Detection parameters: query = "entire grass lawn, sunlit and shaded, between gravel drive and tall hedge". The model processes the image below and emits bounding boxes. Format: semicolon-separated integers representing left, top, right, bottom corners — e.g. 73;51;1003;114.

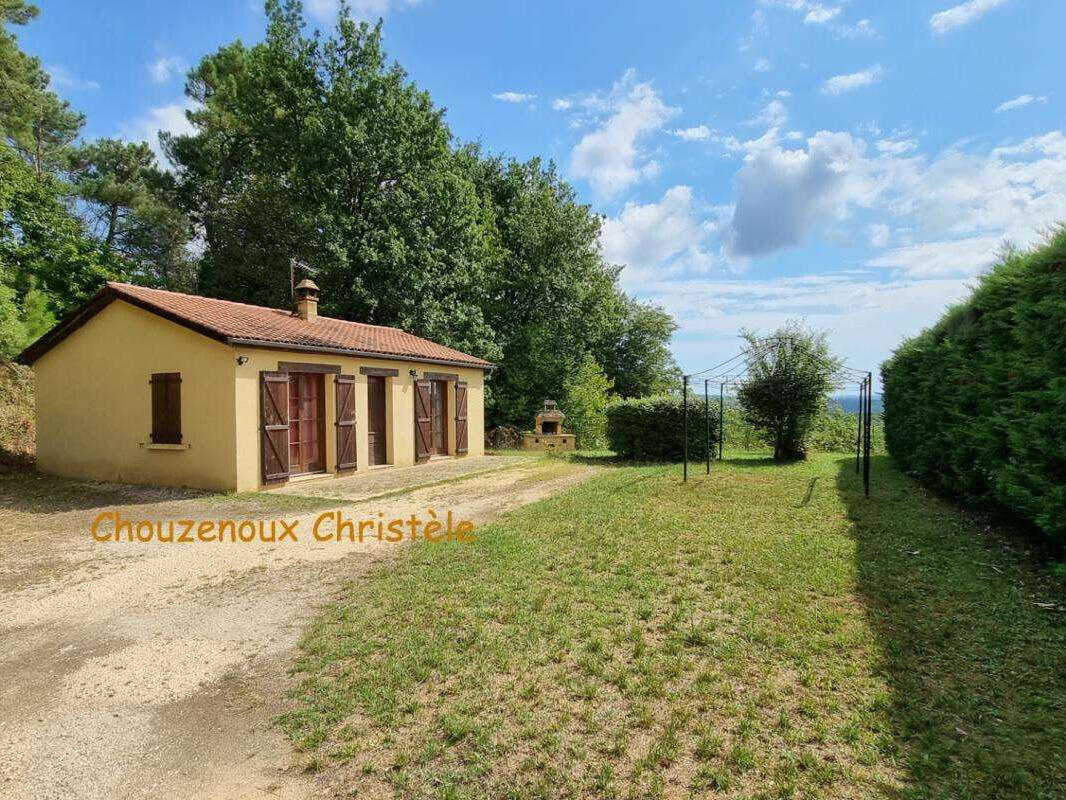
280;455;1066;800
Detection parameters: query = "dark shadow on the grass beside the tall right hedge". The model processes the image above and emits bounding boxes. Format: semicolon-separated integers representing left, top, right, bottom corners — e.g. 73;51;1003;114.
837;455;1066;800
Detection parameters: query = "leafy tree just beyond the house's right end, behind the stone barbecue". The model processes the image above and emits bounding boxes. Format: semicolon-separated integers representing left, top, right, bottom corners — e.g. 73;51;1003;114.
462;146;623;425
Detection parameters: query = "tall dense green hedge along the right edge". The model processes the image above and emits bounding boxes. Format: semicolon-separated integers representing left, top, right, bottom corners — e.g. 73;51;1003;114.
882;231;1066;543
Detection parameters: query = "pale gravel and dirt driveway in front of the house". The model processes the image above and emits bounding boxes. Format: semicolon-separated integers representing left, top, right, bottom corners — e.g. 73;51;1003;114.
0;462;592;800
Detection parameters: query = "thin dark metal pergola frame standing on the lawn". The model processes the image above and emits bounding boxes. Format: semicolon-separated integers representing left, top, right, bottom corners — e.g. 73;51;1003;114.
681;336;873;497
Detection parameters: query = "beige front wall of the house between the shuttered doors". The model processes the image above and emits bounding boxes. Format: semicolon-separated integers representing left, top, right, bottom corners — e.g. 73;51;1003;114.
235;348;485;492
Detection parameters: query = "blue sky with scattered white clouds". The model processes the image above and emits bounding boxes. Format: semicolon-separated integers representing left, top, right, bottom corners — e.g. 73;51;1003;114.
18;0;1066;381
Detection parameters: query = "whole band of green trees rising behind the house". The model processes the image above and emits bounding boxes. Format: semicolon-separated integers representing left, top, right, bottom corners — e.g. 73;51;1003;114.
0;0;677;433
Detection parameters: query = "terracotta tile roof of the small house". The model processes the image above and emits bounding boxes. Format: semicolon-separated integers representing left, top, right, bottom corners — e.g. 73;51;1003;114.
23;282;492;368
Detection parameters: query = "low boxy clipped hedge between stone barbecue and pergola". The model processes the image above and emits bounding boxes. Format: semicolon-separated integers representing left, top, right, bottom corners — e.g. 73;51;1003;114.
607;397;717;461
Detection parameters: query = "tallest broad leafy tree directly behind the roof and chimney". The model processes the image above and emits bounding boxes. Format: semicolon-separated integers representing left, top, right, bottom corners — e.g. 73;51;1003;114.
167;0;497;356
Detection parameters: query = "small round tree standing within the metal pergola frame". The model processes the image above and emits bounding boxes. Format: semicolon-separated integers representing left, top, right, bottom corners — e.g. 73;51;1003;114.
737;321;842;461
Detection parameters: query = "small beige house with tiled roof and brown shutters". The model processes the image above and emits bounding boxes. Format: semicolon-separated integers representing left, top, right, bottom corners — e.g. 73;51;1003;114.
19;281;492;492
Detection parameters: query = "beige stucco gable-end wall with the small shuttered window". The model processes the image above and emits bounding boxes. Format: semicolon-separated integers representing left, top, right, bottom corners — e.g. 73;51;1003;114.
34;301;237;490
